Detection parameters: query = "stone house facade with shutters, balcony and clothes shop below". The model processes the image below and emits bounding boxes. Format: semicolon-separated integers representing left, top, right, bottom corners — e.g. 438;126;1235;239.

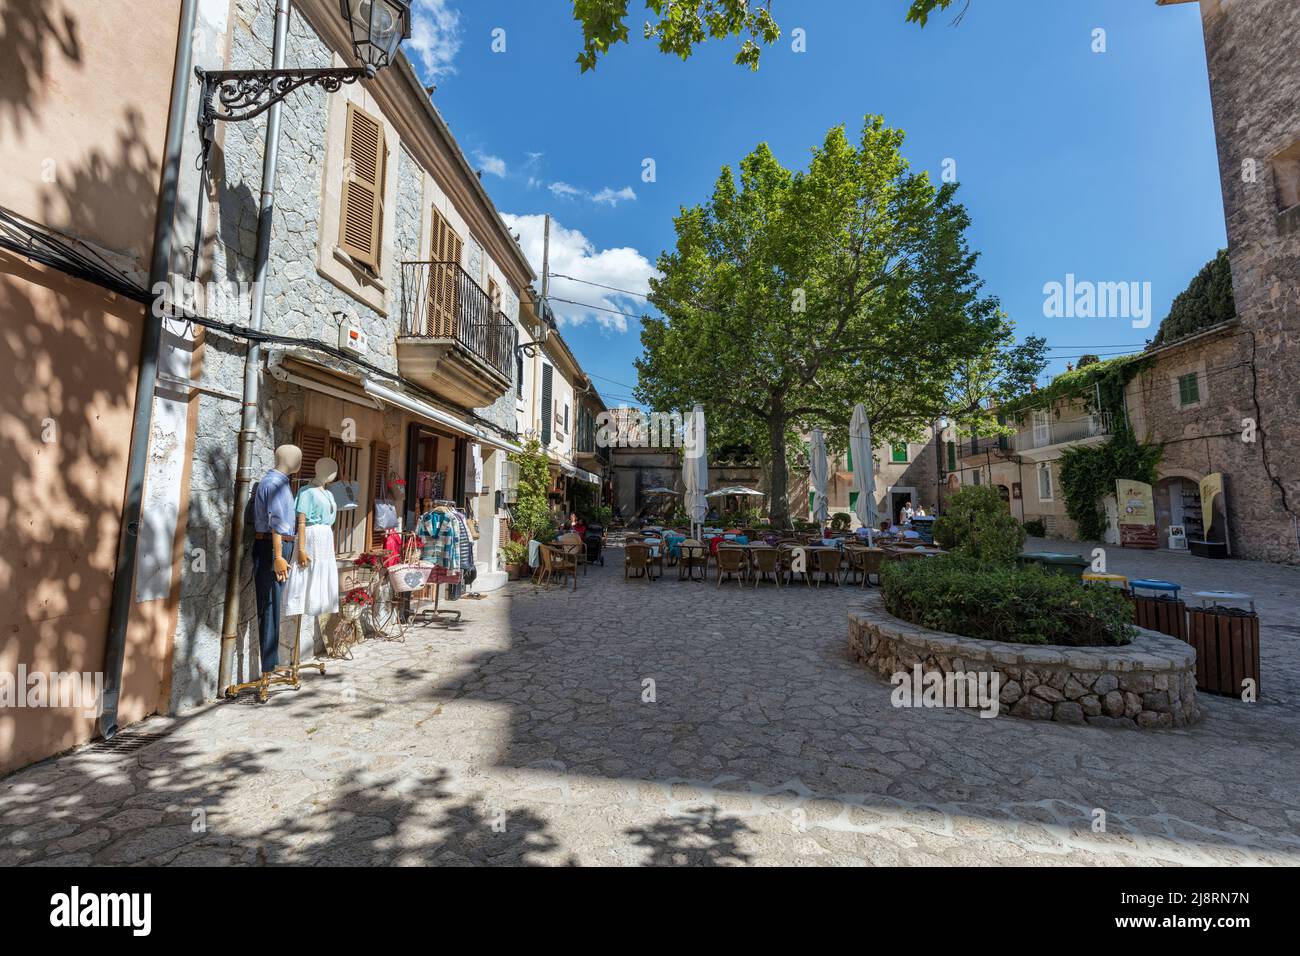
169;0;533;710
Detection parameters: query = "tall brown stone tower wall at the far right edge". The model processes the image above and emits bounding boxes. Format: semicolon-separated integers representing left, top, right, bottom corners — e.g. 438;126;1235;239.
1201;0;1300;562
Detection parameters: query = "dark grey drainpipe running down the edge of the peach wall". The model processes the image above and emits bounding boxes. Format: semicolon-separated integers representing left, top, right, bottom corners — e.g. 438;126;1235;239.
99;0;199;740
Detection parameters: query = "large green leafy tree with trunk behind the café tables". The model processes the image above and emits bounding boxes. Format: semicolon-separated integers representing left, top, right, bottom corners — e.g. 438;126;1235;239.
637;116;1043;522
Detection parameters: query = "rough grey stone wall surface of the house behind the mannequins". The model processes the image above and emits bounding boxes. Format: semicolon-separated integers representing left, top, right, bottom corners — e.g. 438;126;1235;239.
169;0;519;711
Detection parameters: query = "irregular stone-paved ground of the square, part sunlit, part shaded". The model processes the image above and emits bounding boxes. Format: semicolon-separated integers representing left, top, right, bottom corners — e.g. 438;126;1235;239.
0;542;1300;865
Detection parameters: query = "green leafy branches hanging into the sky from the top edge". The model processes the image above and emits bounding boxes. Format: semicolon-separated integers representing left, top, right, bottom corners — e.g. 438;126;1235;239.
573;0;970;73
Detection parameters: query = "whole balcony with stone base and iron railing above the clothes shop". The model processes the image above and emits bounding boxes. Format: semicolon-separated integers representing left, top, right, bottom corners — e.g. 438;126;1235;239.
397;261;519;408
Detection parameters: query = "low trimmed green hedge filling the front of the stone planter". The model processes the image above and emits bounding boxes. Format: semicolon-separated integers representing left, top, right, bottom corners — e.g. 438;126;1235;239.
881;555;1136;646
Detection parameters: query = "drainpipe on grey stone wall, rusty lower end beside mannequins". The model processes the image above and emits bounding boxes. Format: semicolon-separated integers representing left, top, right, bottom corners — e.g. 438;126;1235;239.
217;0;289;697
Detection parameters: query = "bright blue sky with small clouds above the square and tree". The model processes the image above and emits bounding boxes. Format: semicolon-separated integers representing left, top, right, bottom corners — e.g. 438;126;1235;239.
407;0;1226;405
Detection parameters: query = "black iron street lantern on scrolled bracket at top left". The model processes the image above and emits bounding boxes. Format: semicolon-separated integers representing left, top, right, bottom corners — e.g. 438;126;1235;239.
194;0;411;134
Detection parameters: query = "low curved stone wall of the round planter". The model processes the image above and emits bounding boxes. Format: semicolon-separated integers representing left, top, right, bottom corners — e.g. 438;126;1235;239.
849;594;1200;728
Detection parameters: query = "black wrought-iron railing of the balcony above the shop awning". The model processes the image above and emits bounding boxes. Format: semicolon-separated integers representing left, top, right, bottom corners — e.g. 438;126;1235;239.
402;261;519;378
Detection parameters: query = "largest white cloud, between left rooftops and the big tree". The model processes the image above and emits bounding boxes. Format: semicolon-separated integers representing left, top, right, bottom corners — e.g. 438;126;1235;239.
502;213;659;332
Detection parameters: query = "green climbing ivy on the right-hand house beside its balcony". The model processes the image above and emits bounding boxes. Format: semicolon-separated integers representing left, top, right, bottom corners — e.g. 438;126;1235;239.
1061;424;1164;541
